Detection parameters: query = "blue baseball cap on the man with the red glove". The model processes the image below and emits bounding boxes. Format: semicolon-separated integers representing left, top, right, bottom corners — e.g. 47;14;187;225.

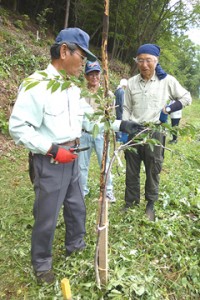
55;27;97;61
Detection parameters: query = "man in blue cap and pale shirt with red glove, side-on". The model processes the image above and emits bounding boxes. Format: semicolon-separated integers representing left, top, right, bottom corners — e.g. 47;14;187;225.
9;28;96;284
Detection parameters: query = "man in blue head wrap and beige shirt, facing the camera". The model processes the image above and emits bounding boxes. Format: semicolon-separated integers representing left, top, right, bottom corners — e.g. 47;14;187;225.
122;44;192;221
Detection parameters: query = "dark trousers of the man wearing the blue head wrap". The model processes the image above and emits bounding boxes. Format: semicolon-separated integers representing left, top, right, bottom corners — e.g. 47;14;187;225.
125;132;165;206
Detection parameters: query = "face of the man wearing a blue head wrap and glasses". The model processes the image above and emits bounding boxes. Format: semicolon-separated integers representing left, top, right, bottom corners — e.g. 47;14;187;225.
137;54;158;80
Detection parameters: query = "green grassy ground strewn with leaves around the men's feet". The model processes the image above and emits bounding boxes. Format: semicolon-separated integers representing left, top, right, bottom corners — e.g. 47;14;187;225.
0;100;200;300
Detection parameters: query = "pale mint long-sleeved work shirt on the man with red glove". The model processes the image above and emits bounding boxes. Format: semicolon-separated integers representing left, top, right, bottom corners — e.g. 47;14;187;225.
9;64;91;154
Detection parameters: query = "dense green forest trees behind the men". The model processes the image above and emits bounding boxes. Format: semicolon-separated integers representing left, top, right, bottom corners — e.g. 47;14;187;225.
0;0;200;97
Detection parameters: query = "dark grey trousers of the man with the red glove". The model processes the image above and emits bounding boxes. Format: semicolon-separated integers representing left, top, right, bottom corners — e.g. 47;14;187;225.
31;154;86;271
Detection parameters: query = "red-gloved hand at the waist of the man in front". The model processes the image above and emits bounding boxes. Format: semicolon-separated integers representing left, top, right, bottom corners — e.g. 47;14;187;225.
47;144;78;163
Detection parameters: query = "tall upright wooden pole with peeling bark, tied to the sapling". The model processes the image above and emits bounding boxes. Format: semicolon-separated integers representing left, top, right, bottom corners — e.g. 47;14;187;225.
95;0;110;286
